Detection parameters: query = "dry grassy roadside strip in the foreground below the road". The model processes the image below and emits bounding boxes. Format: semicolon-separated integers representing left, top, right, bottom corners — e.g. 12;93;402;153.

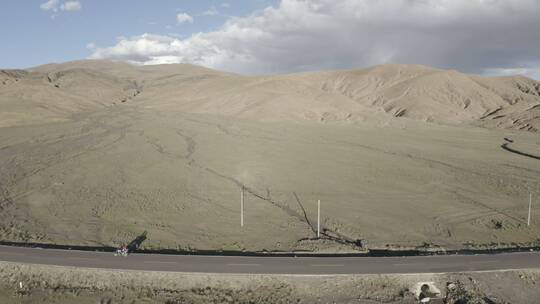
0;262;540;303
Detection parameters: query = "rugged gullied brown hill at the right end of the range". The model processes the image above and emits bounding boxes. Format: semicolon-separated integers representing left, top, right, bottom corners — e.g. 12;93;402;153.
312;65;540;131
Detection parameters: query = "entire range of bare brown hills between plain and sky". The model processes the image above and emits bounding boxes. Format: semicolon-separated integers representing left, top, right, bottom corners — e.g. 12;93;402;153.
0;60;540;131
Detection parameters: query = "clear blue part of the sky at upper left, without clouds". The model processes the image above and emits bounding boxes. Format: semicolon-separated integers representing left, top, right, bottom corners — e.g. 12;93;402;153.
0;0;276;68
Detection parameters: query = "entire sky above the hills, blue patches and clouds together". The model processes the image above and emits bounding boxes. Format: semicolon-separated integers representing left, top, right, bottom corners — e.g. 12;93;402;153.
0;0;540;79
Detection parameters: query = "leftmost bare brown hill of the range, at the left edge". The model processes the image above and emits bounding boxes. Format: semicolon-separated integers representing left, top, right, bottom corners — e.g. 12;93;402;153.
0;68;138;127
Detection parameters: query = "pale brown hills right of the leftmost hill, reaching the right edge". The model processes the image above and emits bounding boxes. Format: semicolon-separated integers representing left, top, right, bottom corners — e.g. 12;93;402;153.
136;65;540;131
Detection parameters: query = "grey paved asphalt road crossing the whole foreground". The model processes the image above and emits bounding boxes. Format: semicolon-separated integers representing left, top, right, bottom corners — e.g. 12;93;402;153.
0;246;540;275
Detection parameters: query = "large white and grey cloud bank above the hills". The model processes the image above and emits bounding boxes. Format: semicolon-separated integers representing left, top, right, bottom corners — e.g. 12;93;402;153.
91;0;540;77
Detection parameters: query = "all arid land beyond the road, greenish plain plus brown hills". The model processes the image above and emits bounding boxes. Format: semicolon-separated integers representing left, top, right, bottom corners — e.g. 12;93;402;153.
0;61;540;252
